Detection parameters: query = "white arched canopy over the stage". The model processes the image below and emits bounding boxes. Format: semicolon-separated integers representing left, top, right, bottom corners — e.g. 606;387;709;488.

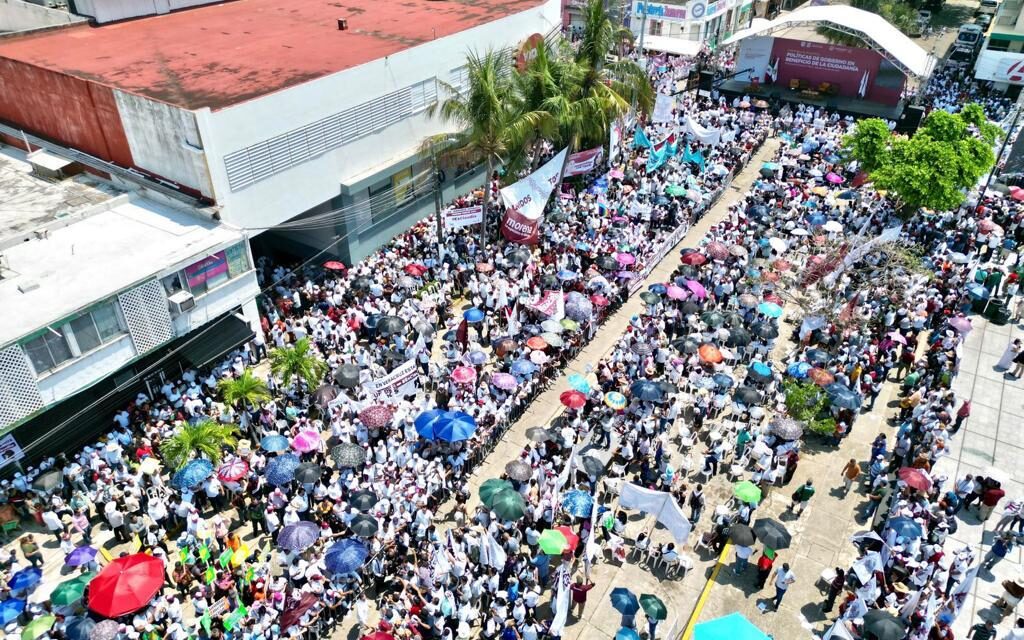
724;4;935;78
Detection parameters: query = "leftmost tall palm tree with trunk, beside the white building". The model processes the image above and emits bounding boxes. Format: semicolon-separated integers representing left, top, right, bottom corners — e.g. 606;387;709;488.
425;51;550;246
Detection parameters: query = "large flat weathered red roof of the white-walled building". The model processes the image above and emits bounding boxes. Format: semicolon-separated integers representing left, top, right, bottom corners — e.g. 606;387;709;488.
0;0;544;109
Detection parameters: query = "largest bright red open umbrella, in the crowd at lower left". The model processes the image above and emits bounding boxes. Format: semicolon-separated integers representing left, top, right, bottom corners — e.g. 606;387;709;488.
89;553;164;617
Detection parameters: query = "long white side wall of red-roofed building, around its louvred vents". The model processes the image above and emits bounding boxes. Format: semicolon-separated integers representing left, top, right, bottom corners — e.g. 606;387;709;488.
197;0;562;228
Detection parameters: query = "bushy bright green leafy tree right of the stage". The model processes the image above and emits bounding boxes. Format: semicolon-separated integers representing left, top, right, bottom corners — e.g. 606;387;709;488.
843;104;1001;217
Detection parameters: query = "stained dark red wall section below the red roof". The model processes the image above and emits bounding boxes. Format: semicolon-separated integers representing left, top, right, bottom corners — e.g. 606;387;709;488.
0;58;134;167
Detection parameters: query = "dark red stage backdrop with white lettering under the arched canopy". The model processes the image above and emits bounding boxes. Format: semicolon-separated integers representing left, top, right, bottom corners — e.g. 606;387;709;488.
769;38;906;105
